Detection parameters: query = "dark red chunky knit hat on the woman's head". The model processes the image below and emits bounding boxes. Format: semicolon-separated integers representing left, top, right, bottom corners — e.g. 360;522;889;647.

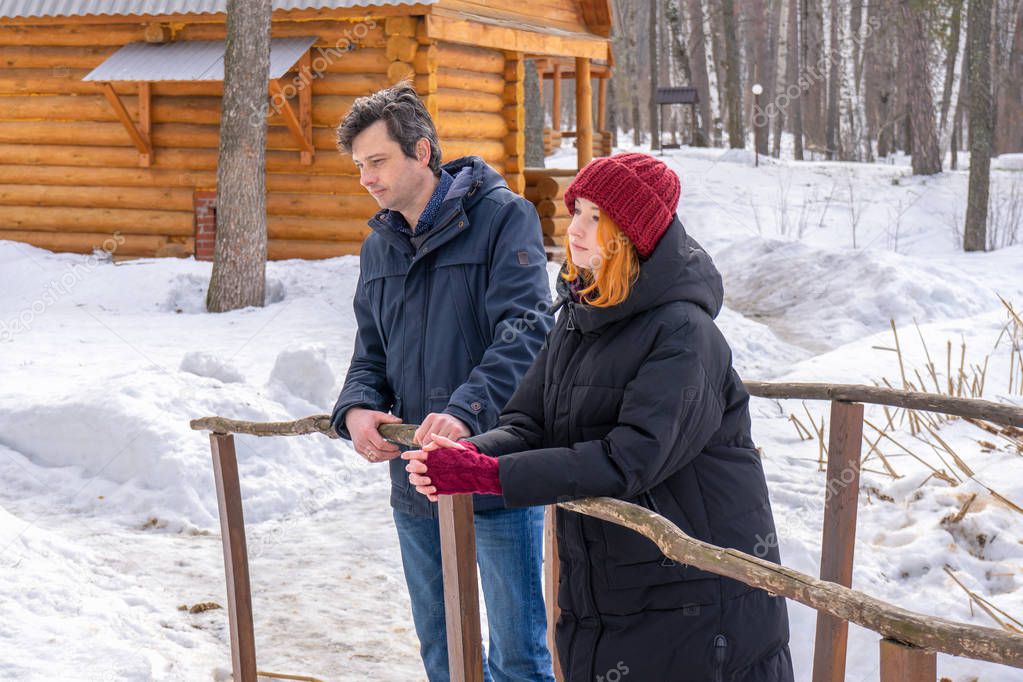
565;152;681;258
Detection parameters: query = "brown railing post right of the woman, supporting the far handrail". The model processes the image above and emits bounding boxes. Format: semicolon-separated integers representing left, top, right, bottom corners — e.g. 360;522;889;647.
813;401;863;682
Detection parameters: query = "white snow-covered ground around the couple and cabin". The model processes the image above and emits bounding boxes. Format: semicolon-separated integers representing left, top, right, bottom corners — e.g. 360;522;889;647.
0;143;1023;682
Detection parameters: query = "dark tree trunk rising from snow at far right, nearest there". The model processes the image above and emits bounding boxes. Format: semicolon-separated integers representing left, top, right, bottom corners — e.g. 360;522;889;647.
963;0;991;252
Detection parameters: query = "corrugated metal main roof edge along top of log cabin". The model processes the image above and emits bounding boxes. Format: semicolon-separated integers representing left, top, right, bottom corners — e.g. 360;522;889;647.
0;0;427;18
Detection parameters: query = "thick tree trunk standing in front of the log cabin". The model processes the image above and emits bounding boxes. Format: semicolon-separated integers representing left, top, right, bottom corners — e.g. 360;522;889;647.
206;0;270;313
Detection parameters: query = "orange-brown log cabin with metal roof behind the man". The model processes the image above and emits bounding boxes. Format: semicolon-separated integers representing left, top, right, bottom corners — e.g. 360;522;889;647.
0;0;612;260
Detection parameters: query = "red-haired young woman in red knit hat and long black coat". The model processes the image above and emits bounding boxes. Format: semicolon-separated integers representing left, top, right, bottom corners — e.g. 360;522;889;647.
403;153;793;682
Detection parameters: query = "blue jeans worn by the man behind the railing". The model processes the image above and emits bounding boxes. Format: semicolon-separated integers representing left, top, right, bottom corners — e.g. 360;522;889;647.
393;507;554;682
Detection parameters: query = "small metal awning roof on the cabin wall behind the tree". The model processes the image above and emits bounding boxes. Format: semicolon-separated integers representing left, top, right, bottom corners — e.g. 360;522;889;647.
82;36;316;82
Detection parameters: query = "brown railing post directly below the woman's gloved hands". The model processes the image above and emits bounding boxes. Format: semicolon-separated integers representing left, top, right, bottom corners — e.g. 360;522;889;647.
438;495;483;682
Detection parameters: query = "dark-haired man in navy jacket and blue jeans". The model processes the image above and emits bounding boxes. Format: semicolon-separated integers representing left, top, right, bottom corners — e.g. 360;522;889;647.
331;83;553;682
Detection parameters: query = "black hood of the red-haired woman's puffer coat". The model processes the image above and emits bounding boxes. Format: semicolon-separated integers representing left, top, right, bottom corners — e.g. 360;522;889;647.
557;217;724;332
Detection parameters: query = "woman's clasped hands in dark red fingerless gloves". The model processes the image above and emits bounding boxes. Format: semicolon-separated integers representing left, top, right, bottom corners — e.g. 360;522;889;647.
401;436;501;502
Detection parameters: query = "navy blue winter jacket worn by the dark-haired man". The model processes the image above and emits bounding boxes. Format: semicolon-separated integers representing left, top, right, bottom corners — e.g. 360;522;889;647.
331;156;552;516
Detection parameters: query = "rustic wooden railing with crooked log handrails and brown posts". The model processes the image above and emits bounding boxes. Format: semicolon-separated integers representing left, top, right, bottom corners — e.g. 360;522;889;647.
191;381;1023;682
